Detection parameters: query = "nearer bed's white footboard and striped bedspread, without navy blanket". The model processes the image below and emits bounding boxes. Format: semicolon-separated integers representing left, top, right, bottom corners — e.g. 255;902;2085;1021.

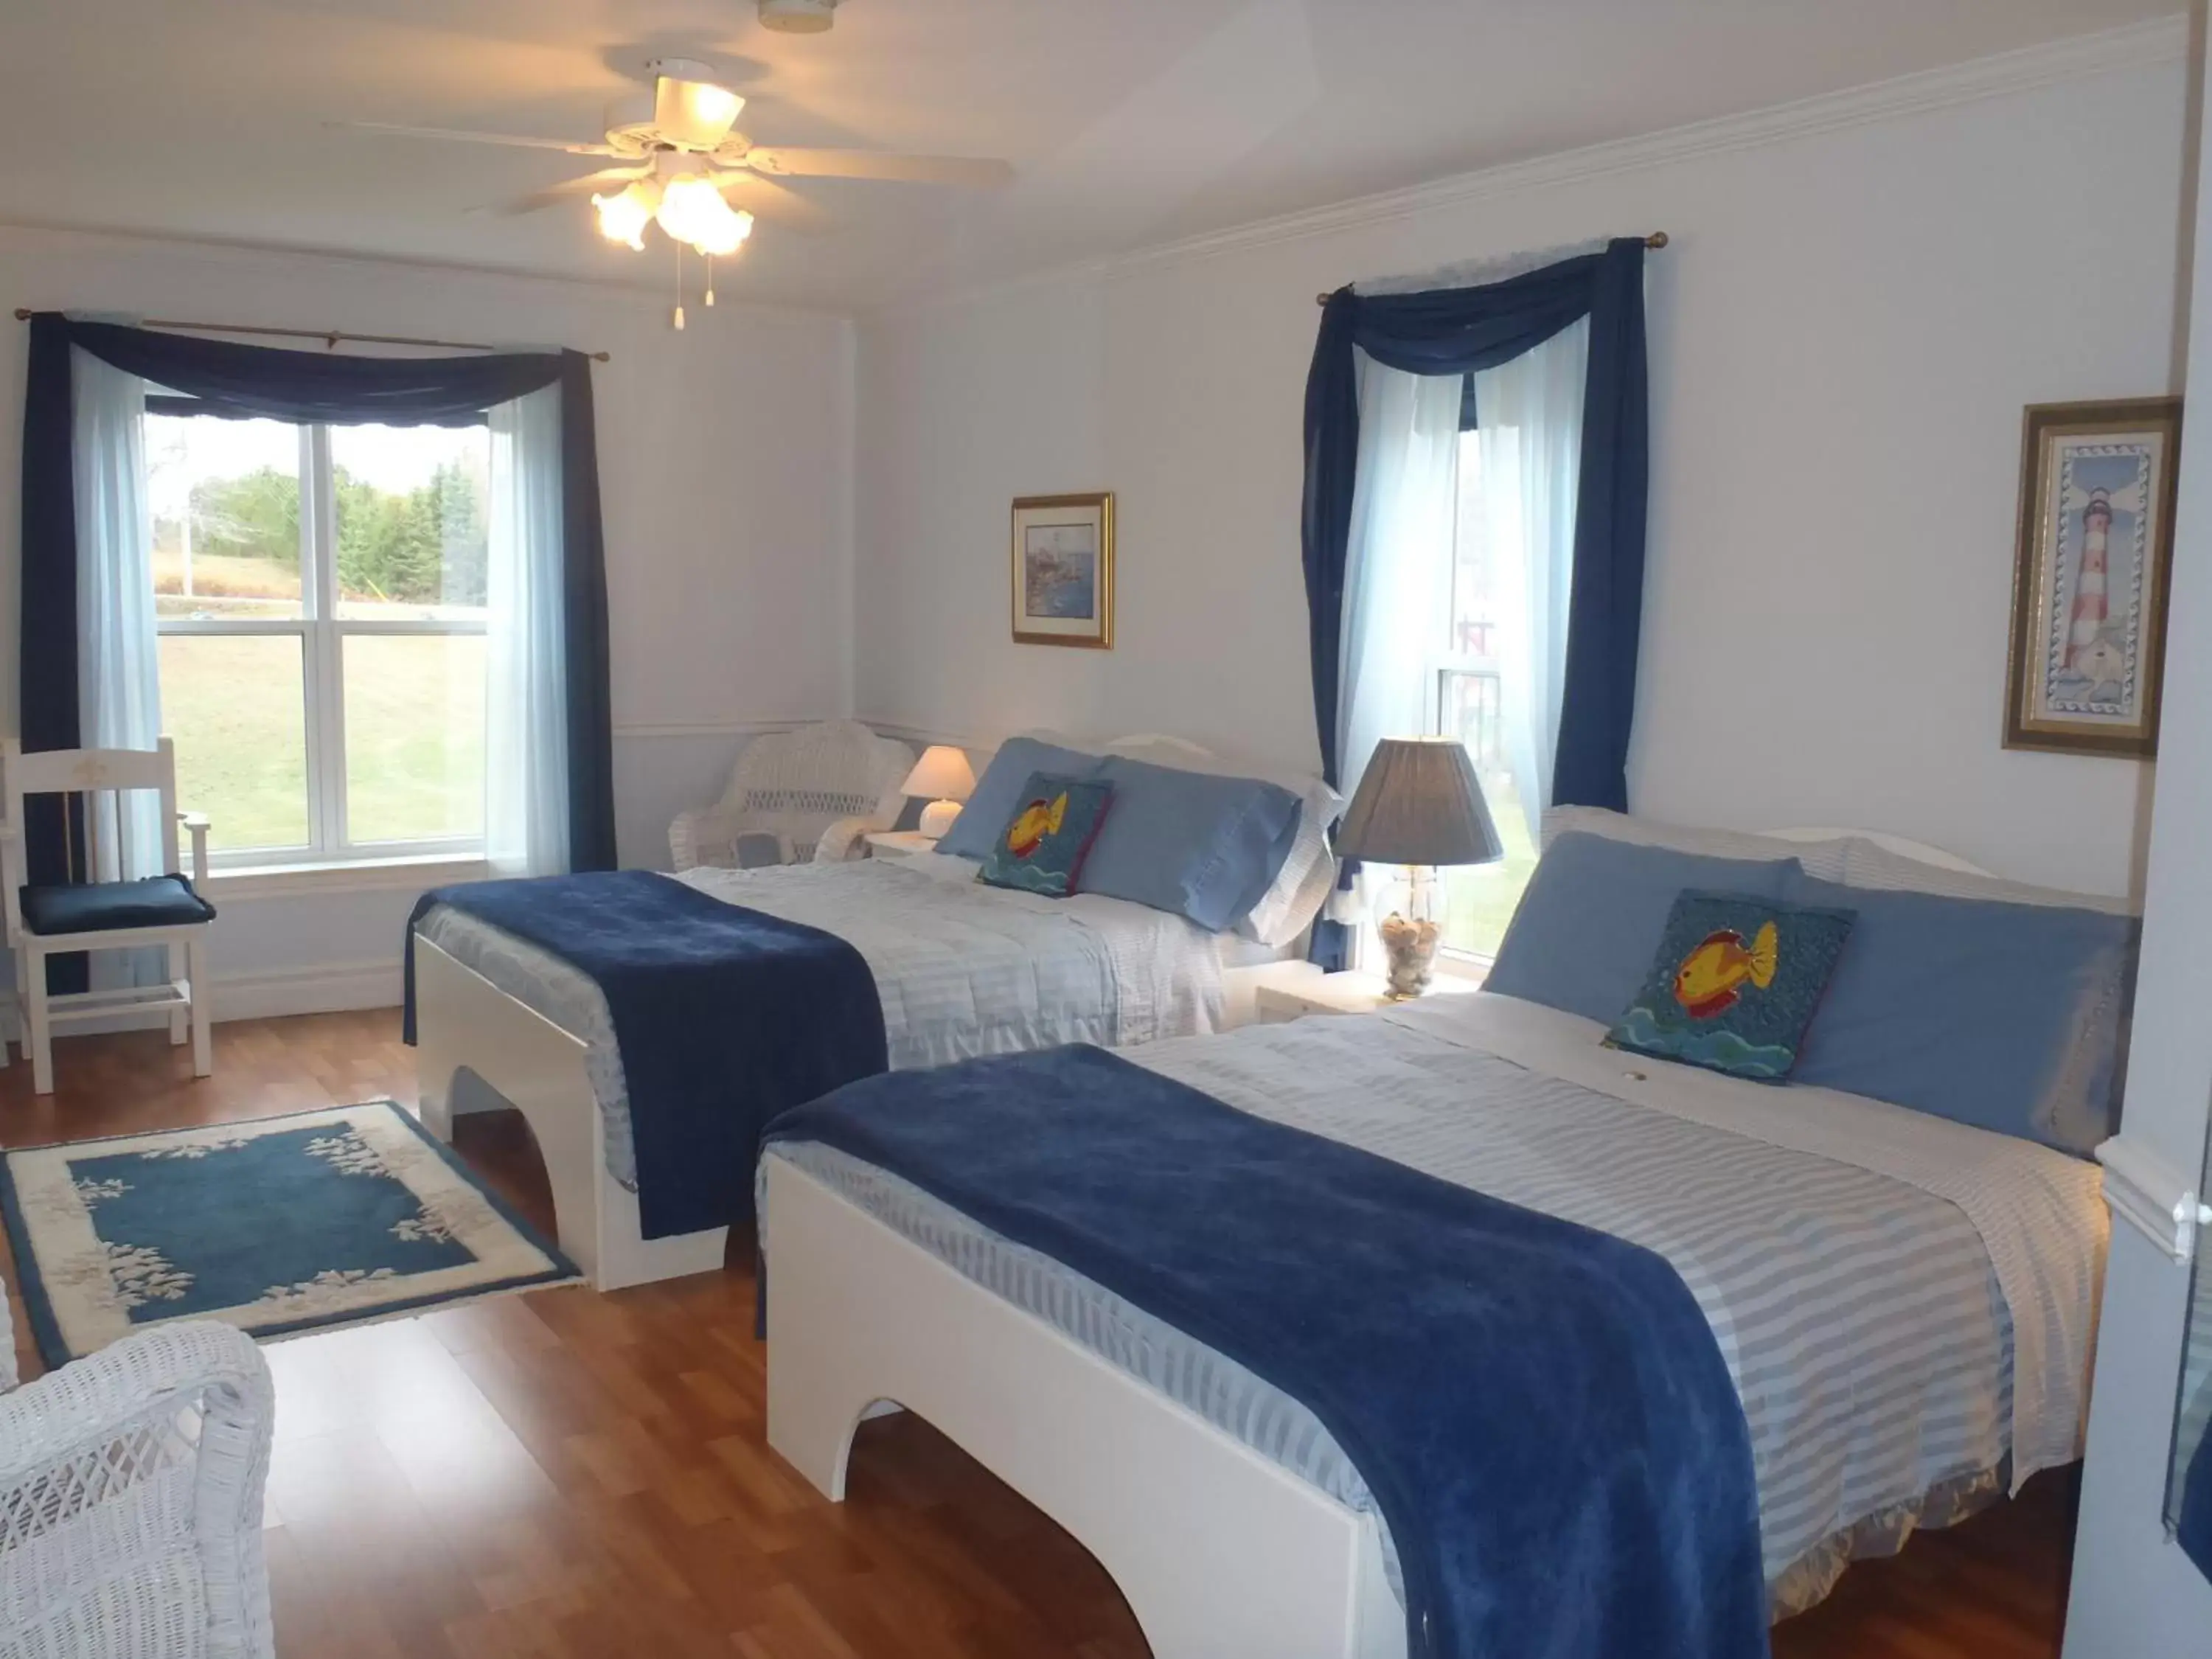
761;841;2108;1659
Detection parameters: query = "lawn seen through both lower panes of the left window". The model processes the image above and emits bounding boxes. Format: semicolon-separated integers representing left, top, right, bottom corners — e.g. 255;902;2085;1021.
161;635;484;849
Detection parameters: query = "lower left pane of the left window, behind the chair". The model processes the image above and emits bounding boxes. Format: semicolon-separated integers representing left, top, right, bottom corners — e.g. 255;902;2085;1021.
161;633;307;852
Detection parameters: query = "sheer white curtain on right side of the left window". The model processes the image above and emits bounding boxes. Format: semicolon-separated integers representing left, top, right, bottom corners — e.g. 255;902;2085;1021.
484;385;568;876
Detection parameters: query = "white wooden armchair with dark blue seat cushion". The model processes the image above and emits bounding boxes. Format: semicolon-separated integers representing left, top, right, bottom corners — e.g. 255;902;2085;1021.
0;737;215;1095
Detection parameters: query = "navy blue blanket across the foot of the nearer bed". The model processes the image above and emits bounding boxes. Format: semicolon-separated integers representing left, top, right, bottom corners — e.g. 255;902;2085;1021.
765;1046;1767;1659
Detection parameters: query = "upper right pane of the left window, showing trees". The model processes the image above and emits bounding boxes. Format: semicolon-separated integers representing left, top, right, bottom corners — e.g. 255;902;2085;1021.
330;427;491;619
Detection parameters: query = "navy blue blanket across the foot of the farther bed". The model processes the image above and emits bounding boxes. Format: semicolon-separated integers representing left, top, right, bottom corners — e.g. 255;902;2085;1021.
405;869;889;1239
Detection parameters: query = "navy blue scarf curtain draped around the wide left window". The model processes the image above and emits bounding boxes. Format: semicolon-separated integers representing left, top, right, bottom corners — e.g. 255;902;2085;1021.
20;312;615;916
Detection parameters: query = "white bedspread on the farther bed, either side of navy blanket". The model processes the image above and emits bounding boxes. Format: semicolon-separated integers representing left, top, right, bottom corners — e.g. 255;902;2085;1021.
418;854;1221;1186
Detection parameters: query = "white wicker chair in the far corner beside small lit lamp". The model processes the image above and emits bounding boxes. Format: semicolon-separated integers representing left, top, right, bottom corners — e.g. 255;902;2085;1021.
668;721;914;869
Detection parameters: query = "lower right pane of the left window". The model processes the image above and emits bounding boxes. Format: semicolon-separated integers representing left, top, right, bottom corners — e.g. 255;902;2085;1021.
345;633;484;841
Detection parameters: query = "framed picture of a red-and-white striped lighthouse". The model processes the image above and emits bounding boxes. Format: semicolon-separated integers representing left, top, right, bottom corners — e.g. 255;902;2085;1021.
2004;398;2181;757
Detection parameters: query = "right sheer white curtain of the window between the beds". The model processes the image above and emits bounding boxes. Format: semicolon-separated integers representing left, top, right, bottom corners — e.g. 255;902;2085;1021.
1475;319;1590;841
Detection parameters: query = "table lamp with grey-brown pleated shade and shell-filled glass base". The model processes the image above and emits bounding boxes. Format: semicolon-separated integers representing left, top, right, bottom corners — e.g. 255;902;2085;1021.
1336;737;1504;1002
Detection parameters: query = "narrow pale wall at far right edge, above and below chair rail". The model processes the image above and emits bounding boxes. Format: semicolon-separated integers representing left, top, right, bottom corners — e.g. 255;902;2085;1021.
2066;26;2212;1659
